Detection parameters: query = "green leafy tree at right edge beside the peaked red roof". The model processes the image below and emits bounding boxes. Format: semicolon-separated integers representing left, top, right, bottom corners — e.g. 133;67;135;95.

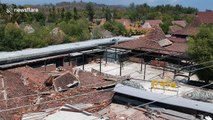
188;25;213;82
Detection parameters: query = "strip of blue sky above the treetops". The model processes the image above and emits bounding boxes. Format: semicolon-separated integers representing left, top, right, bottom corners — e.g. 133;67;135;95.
0;0;213;11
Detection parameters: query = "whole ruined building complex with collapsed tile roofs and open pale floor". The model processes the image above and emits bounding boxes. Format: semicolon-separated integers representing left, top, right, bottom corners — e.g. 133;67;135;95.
0;29;212;120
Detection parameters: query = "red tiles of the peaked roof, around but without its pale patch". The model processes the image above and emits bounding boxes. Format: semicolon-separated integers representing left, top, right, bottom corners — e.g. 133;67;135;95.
113;26;187;54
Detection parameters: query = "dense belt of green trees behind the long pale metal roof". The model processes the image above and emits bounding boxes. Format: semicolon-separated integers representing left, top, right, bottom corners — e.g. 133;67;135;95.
0;3;199;50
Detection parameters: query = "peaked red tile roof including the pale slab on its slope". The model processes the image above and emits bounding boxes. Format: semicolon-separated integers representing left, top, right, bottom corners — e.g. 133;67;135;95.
113;26;187;56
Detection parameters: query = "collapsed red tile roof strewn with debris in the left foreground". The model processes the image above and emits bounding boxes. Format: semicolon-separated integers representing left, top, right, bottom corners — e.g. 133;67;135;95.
0;66;115;119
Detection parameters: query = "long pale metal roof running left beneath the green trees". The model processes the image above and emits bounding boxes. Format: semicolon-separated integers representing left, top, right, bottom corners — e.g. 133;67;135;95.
0;37;135;62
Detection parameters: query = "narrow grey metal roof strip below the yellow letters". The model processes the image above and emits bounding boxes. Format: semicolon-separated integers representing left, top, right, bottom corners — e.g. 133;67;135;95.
114;84;213;114
